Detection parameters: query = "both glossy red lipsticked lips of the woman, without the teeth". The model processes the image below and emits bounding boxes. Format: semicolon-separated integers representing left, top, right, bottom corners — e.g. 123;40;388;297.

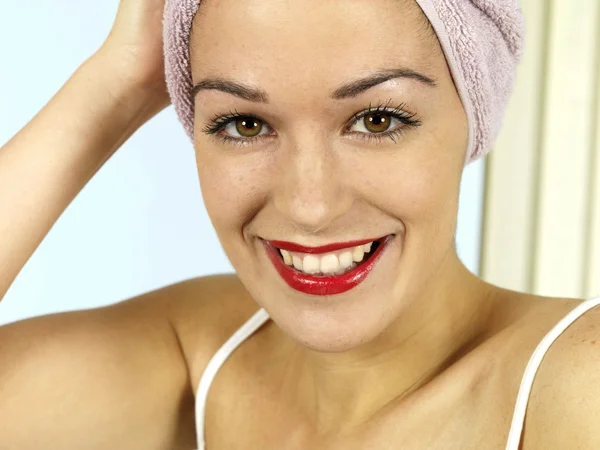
262;235;393;295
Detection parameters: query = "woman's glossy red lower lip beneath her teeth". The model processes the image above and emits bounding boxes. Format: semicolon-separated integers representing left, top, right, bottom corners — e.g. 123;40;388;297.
263;235;392;295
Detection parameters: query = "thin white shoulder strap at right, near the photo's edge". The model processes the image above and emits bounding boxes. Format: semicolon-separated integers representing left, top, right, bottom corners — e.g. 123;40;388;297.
506;297;600;450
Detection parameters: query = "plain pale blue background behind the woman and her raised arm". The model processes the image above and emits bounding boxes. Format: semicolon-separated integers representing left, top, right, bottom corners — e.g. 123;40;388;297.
0;0;484;324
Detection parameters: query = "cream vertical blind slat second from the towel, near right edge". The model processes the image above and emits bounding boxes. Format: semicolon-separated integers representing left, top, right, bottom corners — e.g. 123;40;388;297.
533;0;598;296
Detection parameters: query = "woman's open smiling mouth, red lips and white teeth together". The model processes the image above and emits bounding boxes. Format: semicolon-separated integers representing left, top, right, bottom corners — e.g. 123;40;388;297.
263;235;394;295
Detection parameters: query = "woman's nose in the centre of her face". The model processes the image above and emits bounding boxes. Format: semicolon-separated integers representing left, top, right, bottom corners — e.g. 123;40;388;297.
273;139;353;234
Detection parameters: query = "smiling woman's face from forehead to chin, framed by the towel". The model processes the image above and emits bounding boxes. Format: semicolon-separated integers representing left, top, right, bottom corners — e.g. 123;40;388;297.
191;0;468;351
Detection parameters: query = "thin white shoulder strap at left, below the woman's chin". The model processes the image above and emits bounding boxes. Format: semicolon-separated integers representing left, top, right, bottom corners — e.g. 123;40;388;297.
196;308;269;450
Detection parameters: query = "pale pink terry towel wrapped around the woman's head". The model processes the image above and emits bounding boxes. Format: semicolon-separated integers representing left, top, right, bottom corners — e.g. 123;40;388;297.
164;0;525;165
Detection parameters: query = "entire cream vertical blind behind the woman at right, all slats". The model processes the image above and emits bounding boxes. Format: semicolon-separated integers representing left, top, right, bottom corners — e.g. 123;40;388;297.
482;0;600;297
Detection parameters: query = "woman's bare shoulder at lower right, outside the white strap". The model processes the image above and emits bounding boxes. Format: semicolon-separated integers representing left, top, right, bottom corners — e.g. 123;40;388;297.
523;308;600;450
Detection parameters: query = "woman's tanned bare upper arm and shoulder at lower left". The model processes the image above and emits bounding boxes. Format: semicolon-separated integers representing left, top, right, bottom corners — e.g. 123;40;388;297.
0;284;199;450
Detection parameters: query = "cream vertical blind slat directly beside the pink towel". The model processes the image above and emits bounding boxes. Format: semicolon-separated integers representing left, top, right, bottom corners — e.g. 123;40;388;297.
481;0;548;291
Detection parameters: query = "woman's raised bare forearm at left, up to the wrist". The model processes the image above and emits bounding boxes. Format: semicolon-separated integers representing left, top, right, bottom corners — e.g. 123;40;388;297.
0;53;165;299
